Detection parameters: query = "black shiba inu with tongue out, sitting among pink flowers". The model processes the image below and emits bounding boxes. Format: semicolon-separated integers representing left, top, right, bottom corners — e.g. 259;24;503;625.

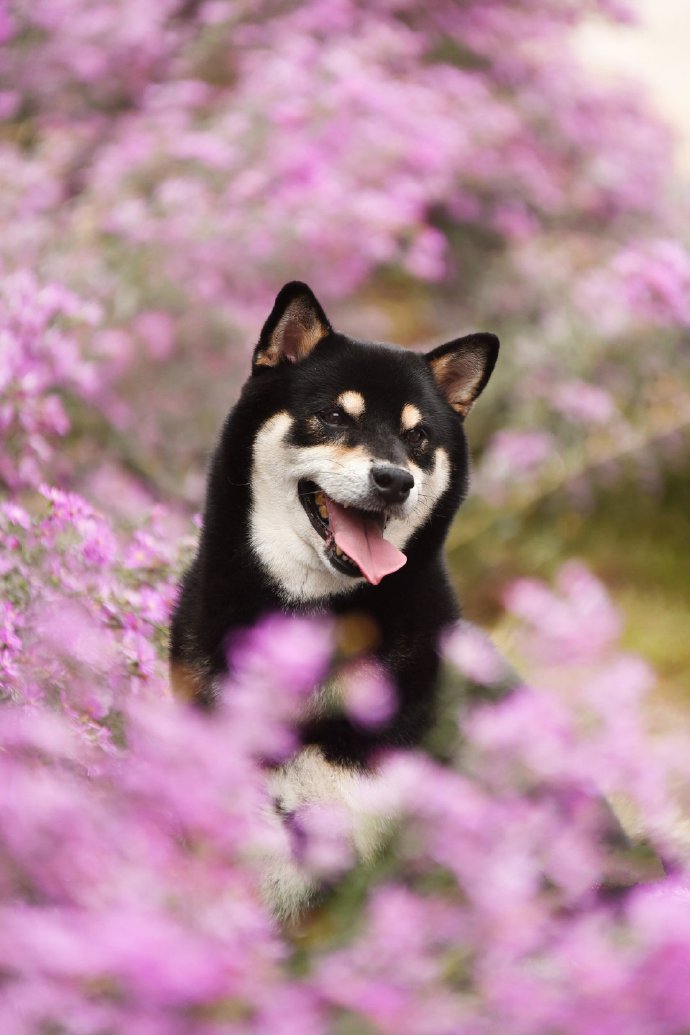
171;283;499;766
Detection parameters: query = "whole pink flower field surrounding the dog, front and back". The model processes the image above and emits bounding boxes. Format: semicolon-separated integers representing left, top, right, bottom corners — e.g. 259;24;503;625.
0;0;690;1035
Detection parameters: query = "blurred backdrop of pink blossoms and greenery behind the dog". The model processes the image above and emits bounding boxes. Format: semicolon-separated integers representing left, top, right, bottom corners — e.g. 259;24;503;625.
0;0;690;697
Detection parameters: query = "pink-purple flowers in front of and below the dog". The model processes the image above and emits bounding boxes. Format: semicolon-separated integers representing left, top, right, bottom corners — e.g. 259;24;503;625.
0;509;690;1035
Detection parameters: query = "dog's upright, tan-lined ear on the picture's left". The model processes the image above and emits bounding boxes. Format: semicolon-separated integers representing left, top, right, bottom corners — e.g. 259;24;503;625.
251;280;332;374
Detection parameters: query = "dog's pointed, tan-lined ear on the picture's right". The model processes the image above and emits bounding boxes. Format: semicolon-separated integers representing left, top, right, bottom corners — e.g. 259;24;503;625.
424;332;499;417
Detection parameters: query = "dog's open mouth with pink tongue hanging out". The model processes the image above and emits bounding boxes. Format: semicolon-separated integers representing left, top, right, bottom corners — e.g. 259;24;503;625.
297;478;407;586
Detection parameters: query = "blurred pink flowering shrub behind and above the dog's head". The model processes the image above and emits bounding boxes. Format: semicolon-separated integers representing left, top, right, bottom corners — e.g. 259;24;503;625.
0;0;690;496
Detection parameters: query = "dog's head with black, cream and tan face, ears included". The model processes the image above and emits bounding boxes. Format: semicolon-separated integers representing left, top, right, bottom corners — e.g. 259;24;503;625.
243;283;499;602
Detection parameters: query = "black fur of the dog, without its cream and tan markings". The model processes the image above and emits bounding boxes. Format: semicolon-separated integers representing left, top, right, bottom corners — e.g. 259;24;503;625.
171;284;498;764
